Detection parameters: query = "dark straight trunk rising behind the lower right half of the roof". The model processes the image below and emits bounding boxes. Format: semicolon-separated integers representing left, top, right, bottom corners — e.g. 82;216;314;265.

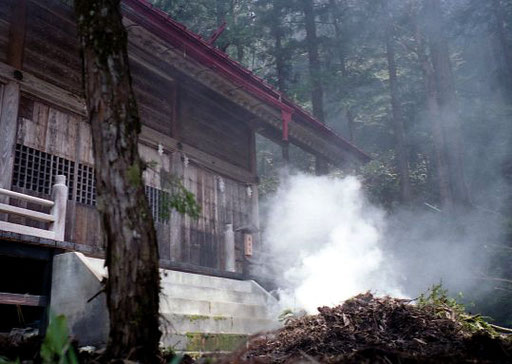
301;0;325;122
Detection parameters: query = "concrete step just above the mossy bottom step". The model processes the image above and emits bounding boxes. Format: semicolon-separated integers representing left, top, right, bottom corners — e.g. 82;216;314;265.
162;313;276;335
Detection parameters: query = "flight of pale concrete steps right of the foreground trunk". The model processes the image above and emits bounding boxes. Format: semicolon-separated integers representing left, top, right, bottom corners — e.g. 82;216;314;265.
160;271;277;352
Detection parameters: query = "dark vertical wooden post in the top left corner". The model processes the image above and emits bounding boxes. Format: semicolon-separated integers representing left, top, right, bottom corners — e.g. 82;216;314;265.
7;0;27;70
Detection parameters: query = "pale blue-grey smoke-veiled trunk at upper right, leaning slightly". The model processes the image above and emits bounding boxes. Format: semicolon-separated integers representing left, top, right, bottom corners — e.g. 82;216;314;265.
426;0;470;206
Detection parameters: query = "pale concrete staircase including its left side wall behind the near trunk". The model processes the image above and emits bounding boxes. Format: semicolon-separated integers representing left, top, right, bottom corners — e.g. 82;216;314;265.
51;253;278;353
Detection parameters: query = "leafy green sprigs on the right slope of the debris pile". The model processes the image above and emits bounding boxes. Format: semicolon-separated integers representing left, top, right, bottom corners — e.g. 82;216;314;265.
418;284;498;337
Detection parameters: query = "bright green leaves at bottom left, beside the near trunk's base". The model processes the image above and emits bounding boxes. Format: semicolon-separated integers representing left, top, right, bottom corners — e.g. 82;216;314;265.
41;315;78;364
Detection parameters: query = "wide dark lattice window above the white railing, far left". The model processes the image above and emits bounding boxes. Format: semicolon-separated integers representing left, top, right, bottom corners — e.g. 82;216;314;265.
12;144;75;199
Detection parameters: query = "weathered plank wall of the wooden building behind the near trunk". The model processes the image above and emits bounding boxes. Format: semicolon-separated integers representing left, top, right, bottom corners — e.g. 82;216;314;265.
0;0;256;271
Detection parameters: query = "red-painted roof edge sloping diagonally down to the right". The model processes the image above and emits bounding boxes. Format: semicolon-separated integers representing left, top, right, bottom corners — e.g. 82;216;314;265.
123;0;370;161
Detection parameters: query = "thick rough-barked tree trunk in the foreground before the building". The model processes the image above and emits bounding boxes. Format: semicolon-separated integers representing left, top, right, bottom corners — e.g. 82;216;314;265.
75;0;161;363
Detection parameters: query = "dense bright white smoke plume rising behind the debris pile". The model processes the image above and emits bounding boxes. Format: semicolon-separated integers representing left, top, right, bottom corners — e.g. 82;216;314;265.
264;174;403;312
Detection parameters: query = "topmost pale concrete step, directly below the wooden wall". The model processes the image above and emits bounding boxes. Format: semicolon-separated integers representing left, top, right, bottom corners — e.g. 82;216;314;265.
161;270;253;292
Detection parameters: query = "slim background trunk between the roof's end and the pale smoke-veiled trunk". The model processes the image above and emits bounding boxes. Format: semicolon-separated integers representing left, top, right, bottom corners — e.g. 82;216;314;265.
385;3;412;203
